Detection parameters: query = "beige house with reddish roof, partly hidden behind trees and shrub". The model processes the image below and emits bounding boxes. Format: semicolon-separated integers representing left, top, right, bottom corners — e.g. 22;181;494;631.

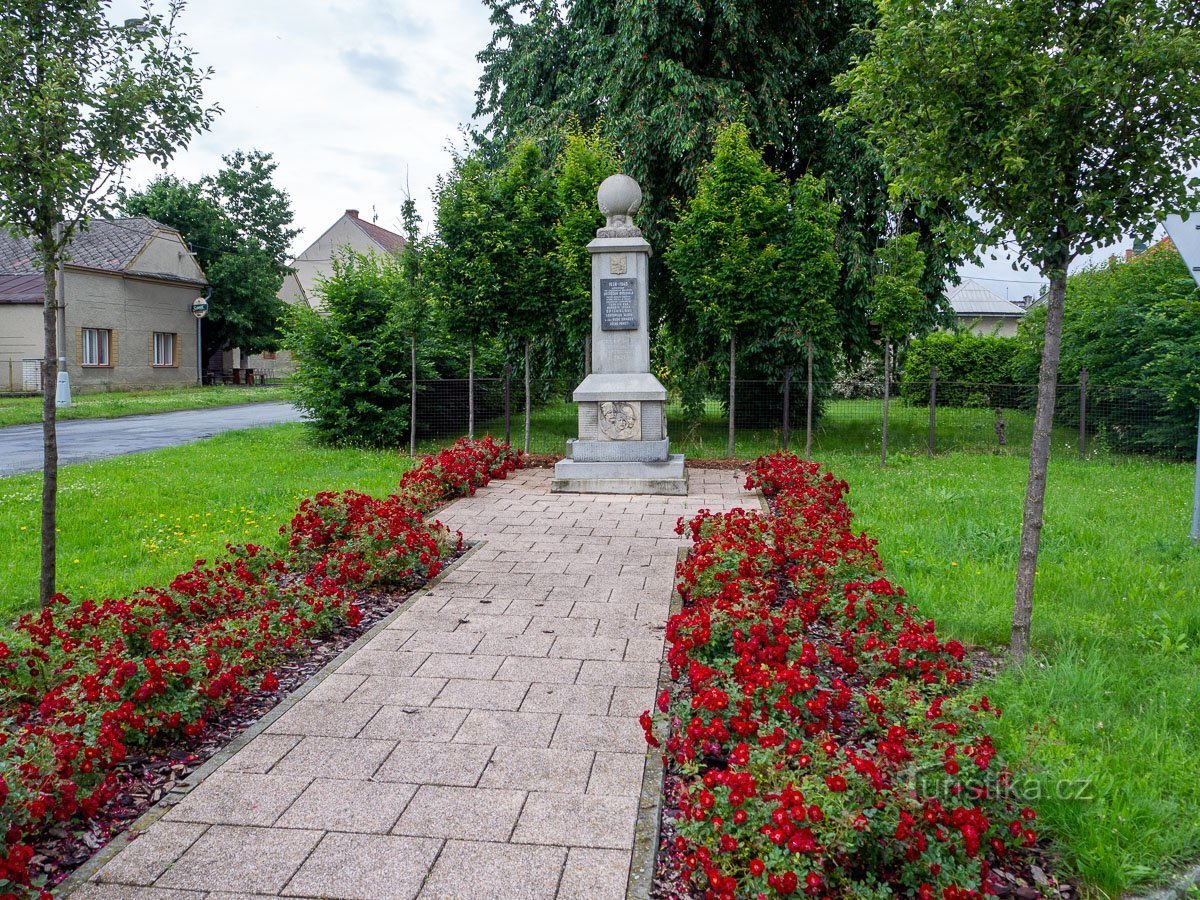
240;209;404;376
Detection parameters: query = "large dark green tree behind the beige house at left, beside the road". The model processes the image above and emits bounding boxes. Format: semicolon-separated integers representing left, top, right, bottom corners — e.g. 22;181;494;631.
121;150;299;358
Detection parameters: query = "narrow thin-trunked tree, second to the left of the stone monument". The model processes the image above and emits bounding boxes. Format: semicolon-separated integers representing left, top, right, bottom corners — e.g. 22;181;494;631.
493;138;562;452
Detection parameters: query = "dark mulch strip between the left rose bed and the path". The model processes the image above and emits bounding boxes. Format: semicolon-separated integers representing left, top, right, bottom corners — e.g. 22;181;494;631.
30;557;454;887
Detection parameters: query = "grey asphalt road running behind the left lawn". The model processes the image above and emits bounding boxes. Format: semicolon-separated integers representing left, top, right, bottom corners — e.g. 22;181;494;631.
0;403;301;478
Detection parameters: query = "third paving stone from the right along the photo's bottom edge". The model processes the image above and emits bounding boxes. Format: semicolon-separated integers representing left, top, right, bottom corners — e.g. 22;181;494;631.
283;834;442;900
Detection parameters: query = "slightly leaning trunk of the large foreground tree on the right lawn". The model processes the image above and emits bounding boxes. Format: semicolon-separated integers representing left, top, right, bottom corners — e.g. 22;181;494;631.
1009;260;1067;664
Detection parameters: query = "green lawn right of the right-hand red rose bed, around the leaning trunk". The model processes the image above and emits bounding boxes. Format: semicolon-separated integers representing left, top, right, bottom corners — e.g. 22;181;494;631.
835;454;1200;896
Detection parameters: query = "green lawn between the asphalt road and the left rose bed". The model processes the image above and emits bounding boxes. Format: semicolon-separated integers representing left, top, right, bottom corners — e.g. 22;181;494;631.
0;425;412;634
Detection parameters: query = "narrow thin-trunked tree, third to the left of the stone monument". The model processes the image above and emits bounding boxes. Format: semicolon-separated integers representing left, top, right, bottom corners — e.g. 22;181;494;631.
426;154;502;437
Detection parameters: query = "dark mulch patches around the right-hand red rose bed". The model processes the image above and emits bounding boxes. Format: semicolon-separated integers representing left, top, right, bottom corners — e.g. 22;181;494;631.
650;504;1080;900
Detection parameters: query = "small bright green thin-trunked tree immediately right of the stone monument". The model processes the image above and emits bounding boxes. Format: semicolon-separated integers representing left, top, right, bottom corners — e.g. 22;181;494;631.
666;124;788;458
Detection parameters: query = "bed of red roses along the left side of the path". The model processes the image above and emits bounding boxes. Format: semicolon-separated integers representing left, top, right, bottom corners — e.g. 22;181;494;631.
0;438;521;898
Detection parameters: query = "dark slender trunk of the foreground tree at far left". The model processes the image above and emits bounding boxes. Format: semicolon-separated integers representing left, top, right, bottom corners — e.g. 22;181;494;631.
37;240;61;610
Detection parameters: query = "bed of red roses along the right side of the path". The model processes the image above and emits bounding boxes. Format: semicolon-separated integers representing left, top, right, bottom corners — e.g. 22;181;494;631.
642;455;1037;900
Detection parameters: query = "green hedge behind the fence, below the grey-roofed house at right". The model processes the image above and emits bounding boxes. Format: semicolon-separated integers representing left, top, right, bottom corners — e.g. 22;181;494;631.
900;331;1017;407
